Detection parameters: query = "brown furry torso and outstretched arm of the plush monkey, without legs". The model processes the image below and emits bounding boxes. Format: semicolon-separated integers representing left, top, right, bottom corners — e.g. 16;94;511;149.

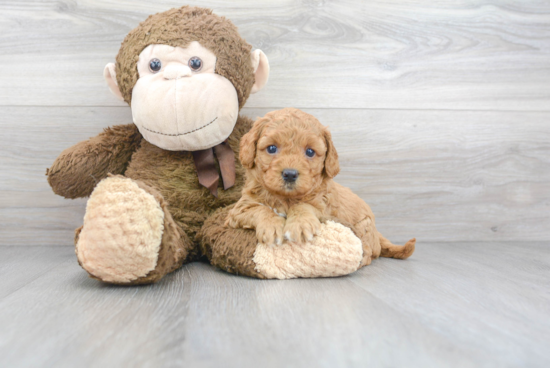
47;116;253;262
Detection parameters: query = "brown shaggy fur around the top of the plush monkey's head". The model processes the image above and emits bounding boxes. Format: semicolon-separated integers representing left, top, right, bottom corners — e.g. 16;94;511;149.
116;6;254;108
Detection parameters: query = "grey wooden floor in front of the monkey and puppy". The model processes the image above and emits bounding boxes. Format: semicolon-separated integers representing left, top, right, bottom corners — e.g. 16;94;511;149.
0;242;550;368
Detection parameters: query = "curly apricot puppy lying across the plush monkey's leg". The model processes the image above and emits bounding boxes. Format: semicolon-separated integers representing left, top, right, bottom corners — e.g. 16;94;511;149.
226;108;416;266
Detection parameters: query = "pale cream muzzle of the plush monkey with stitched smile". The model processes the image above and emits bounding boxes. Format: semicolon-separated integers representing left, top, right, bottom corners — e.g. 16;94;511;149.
131;69;239;151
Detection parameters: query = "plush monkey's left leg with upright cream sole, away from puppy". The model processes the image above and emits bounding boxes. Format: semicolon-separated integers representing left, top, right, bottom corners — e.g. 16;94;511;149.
75;175;193;285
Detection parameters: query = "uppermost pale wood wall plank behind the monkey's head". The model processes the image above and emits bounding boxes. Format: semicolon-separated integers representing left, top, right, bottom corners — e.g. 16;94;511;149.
0;0;550;111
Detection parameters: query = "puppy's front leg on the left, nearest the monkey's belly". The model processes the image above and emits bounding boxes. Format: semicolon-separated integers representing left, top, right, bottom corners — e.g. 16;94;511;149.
225;196;285;245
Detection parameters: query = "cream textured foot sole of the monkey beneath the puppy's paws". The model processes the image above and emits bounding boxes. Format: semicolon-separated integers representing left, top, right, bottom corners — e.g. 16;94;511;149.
253;221;363;279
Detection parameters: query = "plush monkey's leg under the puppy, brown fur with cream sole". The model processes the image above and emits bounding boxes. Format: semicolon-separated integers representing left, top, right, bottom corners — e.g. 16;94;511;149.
197;206;363;279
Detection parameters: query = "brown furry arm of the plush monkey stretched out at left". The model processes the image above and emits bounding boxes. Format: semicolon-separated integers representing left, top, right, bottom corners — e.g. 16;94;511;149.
46;124;141;199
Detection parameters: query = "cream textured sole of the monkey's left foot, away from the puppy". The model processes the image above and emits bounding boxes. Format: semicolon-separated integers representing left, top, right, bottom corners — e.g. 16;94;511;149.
77;177;164;283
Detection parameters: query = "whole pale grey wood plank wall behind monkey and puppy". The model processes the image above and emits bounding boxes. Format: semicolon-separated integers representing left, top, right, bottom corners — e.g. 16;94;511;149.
0;0;550;246
